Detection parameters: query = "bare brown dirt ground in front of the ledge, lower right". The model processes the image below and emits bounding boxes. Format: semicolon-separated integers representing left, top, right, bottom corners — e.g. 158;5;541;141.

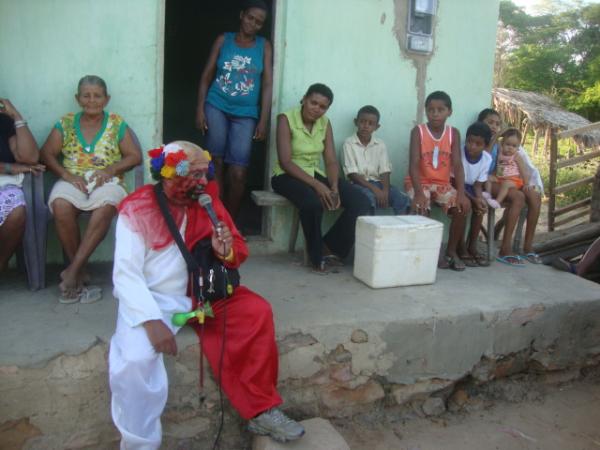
334;373;600;450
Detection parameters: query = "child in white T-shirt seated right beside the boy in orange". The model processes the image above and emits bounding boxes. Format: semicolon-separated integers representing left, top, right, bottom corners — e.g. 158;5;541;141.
458;122;492;267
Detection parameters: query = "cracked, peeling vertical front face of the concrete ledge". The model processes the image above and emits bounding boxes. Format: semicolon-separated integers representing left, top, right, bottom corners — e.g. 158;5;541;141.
0;301;600;450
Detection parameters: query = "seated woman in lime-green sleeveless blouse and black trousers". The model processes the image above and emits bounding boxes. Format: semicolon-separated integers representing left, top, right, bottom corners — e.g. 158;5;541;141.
271;83;371;274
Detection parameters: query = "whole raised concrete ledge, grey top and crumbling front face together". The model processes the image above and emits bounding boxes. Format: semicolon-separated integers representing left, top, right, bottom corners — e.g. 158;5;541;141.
0;256;600;450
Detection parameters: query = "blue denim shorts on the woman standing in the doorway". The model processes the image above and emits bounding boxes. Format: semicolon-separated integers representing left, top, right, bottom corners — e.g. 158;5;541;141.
204;102;256;167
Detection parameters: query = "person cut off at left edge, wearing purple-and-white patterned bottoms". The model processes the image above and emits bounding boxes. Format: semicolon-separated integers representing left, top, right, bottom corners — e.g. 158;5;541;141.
0;98;46;272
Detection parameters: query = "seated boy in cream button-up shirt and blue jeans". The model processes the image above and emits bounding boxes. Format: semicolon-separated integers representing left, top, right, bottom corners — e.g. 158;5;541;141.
342;105;410;214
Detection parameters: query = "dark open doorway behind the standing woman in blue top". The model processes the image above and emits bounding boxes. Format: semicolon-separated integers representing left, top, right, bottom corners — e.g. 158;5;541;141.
163;0;274;235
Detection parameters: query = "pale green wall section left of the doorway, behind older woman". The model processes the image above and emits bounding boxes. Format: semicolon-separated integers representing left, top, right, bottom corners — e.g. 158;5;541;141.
0;0;164;262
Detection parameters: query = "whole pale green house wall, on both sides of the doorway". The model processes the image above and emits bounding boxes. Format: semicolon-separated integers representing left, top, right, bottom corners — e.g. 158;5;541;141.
0;0;499;261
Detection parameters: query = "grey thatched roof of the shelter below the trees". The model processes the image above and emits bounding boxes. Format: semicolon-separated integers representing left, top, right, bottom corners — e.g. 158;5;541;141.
493;88;600;147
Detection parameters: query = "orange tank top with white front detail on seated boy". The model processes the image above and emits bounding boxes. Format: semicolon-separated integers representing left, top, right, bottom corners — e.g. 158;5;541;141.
419;123;452;184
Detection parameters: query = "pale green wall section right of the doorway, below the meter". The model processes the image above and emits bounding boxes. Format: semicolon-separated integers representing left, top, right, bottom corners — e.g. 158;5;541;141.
269;0;499;250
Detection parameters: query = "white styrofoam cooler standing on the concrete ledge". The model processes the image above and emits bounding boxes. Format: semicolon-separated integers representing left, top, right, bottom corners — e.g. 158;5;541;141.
354;216;444;288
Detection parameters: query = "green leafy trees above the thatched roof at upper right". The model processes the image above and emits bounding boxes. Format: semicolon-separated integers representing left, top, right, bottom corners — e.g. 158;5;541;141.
495;0;600;121
